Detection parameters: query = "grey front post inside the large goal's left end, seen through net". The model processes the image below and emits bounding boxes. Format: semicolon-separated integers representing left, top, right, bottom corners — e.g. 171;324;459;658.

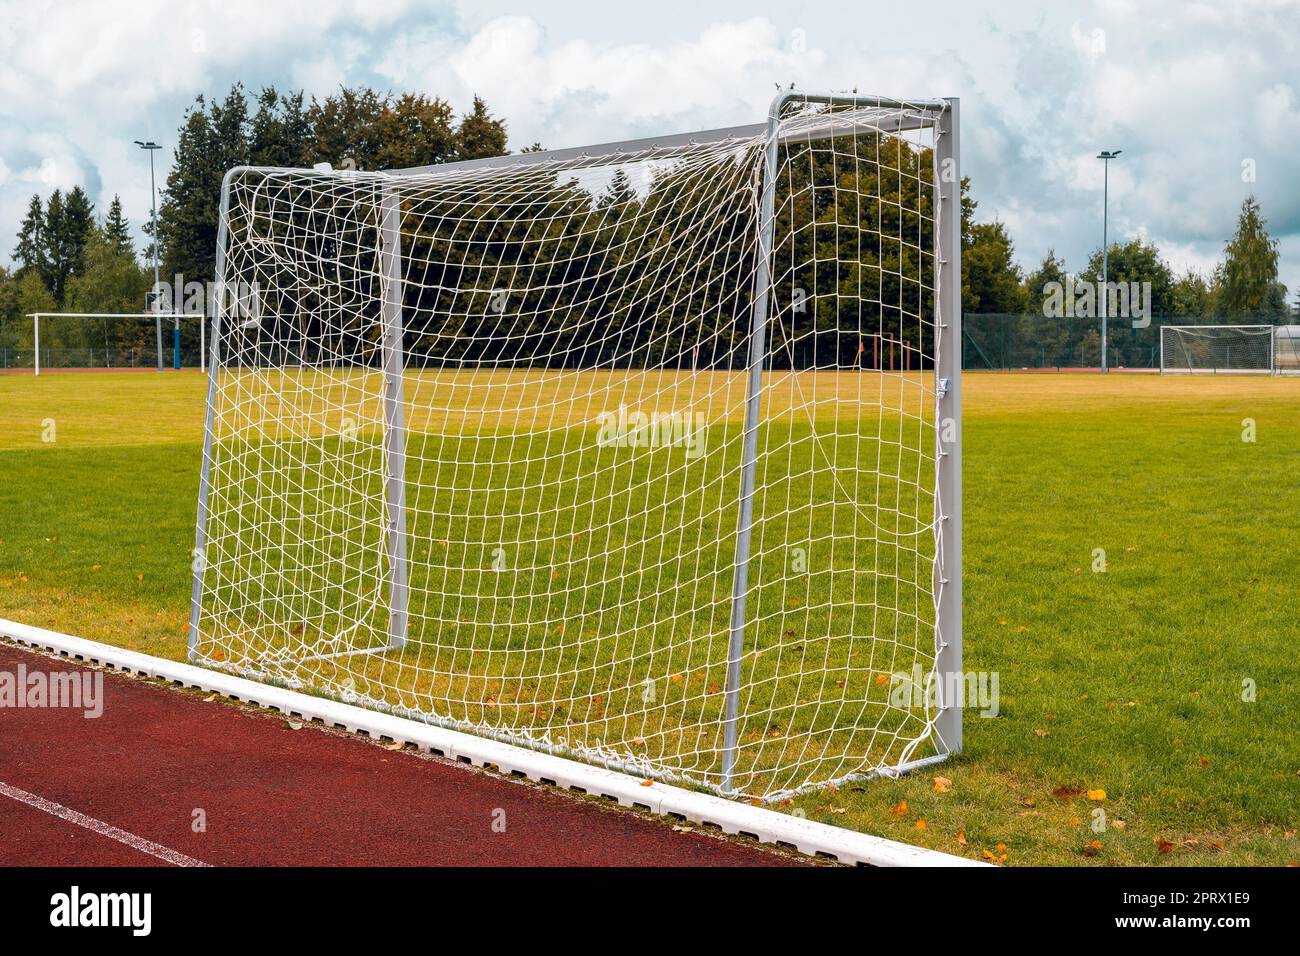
380;189;410;649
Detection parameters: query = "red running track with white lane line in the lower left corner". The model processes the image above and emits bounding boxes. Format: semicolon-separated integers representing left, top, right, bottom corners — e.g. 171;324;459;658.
0;644;801;866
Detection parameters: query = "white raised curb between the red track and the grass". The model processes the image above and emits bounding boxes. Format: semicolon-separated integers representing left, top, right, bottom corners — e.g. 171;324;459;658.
0;618;985;866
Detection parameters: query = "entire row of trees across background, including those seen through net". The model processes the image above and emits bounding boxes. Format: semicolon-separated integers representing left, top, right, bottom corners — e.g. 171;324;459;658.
0;85;1300;367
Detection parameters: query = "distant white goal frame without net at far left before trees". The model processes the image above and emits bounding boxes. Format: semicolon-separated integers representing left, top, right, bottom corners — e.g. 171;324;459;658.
27;312;207;375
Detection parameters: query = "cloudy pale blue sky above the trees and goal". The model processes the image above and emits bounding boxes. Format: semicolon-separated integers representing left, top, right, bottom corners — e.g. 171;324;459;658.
0;0;1300;299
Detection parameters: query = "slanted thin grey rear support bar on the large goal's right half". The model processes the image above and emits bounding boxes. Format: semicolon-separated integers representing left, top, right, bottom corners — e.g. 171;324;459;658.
722;94;787;793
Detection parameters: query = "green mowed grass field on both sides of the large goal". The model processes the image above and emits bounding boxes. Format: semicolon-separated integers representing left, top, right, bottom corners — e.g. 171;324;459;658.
0;372;1300;865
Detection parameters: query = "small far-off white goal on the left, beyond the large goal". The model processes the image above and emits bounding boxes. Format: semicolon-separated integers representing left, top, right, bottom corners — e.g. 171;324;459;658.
24;312;207;375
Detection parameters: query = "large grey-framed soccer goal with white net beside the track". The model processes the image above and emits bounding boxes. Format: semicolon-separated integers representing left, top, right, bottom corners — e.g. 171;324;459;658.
190;92;962;799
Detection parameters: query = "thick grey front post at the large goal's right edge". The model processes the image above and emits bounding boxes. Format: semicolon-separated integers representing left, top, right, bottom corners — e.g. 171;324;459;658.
933;98;965;753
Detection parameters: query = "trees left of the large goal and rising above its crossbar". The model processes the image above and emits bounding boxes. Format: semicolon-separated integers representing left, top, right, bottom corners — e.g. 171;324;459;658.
0;83;512;364
